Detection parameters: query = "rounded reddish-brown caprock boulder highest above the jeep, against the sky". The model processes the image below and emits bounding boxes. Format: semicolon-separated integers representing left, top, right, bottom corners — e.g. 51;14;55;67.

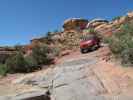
63;18;88;31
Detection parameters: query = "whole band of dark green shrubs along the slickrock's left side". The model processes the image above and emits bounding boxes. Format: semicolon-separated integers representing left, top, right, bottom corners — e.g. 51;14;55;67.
0;45;59;74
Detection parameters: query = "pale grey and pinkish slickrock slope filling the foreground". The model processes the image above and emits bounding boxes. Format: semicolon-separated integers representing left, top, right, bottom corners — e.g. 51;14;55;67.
0;48;133;100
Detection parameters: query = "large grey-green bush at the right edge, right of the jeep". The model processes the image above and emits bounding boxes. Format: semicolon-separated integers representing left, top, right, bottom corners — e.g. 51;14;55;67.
106;23;133;65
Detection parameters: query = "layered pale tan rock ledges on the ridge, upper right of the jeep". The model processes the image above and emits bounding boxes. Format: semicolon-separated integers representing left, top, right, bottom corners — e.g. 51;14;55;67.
93;12;133;36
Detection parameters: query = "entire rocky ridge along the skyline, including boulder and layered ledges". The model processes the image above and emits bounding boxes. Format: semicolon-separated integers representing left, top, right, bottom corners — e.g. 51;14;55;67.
22;12;133;54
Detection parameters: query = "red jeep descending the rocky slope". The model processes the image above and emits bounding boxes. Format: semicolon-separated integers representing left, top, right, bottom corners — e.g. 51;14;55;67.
80;35;100;53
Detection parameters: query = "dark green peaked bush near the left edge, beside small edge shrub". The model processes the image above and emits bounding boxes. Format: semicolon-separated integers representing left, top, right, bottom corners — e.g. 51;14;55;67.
6;52;28;73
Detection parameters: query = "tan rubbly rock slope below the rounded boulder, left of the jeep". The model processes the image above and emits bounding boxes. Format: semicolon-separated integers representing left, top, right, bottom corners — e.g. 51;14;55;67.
29;30;82;51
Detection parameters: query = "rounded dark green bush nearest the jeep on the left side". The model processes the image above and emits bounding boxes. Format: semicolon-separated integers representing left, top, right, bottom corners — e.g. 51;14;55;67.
32;45;52;65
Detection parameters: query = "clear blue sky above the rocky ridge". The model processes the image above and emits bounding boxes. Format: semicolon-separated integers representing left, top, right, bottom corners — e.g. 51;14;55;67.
0;0;133;46
